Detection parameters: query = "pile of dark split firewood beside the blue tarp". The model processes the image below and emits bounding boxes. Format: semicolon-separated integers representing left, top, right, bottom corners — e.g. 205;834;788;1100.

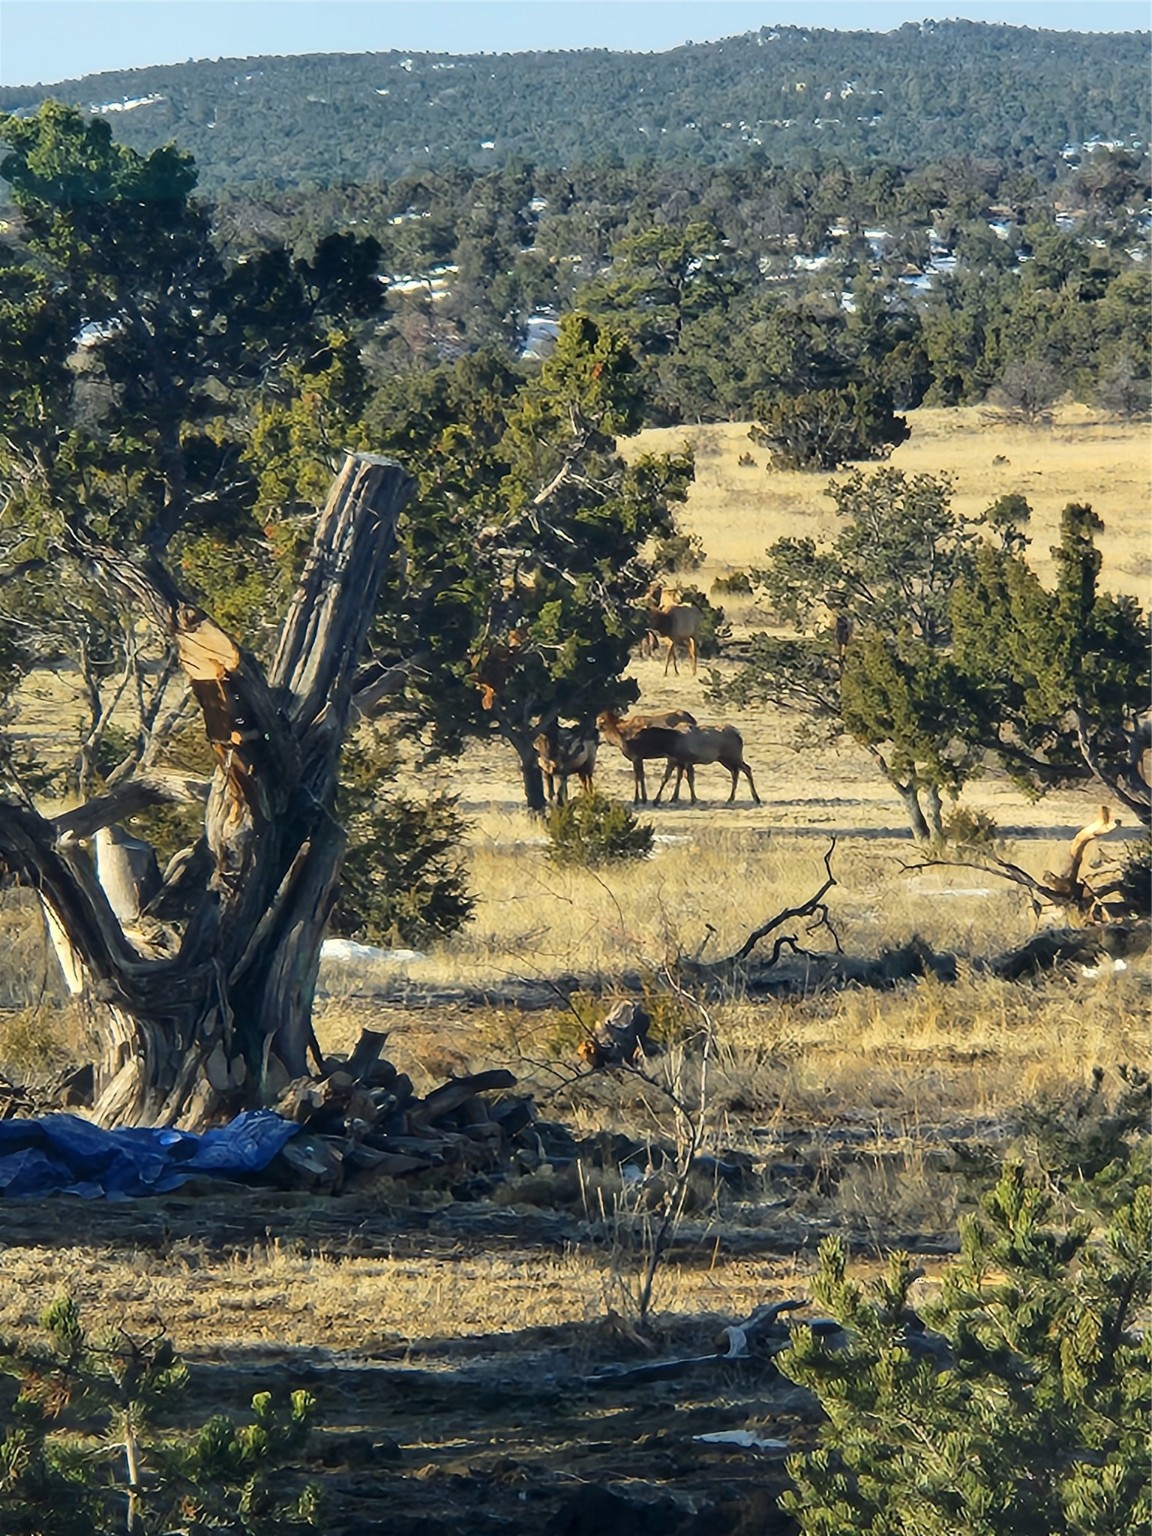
273;1029;535;1192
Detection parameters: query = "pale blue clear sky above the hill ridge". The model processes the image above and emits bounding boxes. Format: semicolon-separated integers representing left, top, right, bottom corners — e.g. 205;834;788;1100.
0;0;1152;84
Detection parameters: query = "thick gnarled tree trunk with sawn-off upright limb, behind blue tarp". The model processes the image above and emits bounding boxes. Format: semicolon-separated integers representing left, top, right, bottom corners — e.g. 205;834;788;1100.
0;455;413;1127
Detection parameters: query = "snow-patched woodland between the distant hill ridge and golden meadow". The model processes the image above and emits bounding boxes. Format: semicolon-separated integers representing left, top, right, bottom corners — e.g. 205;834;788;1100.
202;149;1149;436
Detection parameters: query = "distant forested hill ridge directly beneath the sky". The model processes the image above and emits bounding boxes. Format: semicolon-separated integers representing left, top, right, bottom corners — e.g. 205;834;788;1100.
0;22;1149;192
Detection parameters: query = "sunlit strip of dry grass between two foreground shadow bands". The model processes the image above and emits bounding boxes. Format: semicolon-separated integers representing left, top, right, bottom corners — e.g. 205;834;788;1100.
0;1241;794;1364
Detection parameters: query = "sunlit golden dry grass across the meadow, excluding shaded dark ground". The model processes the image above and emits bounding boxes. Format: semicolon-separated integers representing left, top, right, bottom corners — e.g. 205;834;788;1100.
0;410;1152;1350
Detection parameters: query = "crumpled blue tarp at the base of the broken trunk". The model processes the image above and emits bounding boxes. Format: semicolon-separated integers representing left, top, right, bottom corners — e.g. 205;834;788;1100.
0;1109;300;1200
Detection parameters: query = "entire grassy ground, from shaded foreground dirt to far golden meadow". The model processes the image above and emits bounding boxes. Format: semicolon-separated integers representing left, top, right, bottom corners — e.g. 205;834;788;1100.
0;412;1149;1536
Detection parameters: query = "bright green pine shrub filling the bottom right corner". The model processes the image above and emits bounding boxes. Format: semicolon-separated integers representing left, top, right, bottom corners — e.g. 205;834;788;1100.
777;1166;1152;1536
